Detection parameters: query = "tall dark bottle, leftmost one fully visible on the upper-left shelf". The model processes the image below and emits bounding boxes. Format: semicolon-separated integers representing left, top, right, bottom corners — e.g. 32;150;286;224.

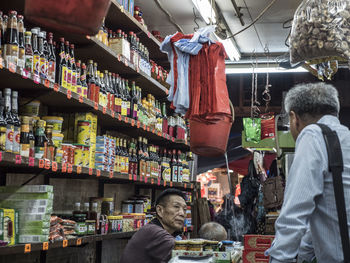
4;11;18;70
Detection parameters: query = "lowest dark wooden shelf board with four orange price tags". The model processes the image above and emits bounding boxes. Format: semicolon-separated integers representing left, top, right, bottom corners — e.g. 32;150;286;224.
0;231;136;256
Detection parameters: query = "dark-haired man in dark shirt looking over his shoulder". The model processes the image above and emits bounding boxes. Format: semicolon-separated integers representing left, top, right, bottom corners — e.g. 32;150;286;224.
120;189;187;263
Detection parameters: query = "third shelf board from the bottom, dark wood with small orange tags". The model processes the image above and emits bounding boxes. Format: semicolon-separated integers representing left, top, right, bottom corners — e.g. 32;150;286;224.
0;68;190;150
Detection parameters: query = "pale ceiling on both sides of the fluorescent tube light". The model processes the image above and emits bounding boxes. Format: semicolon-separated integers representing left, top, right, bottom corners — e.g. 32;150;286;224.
135;0;301;59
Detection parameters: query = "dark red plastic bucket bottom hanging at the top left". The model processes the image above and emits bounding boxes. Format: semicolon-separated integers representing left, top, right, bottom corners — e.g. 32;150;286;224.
24;0;110;35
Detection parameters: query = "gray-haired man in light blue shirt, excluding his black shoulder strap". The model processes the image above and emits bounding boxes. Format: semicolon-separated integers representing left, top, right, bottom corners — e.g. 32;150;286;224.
266;83;350;263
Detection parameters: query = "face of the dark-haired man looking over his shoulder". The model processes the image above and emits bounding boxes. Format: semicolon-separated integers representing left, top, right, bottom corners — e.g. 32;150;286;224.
157;195;187;232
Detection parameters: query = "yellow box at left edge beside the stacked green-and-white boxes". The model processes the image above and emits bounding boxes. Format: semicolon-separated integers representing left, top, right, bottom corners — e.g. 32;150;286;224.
0;208;19;245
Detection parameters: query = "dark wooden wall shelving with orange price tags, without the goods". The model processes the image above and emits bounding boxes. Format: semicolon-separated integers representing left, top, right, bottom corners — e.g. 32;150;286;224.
0;0;199;263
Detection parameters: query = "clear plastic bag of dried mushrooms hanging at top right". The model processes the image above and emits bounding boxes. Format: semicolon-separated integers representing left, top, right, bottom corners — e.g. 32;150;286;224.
290;0;350;64
